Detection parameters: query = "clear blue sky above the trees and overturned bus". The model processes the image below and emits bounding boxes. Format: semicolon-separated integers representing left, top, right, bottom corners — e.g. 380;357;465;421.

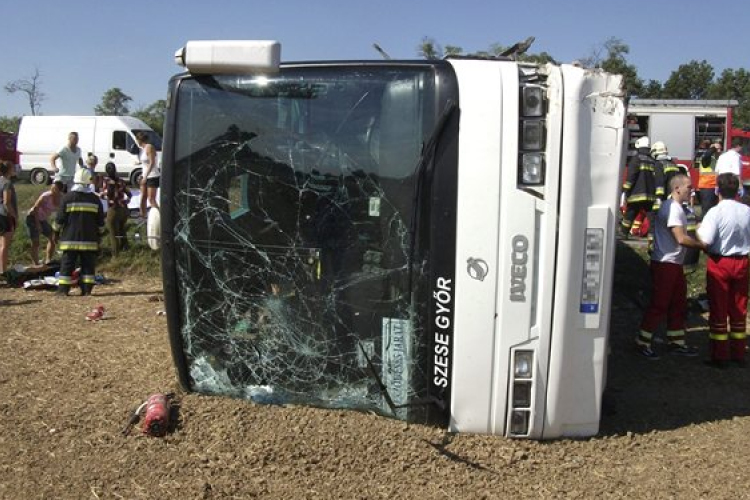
0;0;750;116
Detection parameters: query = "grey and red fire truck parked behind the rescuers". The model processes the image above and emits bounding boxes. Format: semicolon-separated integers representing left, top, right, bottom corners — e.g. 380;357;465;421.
627;99;750;184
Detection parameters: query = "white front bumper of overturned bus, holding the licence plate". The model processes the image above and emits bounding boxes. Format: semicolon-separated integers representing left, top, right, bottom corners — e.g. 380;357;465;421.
543;66;625;438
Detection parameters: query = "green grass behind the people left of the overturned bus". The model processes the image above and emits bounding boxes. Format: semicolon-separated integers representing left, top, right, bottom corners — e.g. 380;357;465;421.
10;182;161;278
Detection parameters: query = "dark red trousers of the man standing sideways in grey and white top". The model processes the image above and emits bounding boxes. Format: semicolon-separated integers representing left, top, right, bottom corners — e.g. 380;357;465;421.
641;260;687;333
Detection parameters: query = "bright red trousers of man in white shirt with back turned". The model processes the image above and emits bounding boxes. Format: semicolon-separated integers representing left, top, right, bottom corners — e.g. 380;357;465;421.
706;256;748;361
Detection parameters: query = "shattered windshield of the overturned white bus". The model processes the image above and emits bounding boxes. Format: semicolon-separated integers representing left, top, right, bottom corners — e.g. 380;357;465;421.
172;67;435;418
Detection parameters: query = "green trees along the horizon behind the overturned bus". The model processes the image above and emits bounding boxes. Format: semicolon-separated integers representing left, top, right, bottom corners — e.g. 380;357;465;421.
0;37;750;134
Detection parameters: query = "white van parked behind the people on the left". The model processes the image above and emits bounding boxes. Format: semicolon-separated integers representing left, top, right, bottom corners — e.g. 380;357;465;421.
17;116;161;185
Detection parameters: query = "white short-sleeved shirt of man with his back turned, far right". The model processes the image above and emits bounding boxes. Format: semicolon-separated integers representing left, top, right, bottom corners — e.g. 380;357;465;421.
698;200;750;256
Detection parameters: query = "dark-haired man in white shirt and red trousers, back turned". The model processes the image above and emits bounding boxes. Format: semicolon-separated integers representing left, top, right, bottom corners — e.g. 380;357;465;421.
698;173;750;368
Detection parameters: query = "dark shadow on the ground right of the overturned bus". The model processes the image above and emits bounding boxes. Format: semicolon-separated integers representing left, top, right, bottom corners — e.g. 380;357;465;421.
600;241;750;435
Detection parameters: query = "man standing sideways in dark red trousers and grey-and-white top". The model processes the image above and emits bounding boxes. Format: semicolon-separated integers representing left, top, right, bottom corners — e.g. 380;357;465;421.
635;174;704;360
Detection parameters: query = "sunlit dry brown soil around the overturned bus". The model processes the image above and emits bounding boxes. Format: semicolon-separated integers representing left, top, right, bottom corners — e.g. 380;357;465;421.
0;256;750;499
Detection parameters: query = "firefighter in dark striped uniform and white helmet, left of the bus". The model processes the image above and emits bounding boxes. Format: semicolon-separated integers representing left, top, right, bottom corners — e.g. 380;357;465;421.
56;168;104;295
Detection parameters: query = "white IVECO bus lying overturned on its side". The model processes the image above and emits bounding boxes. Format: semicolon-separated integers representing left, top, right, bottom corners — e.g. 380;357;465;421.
160;41;626;439
